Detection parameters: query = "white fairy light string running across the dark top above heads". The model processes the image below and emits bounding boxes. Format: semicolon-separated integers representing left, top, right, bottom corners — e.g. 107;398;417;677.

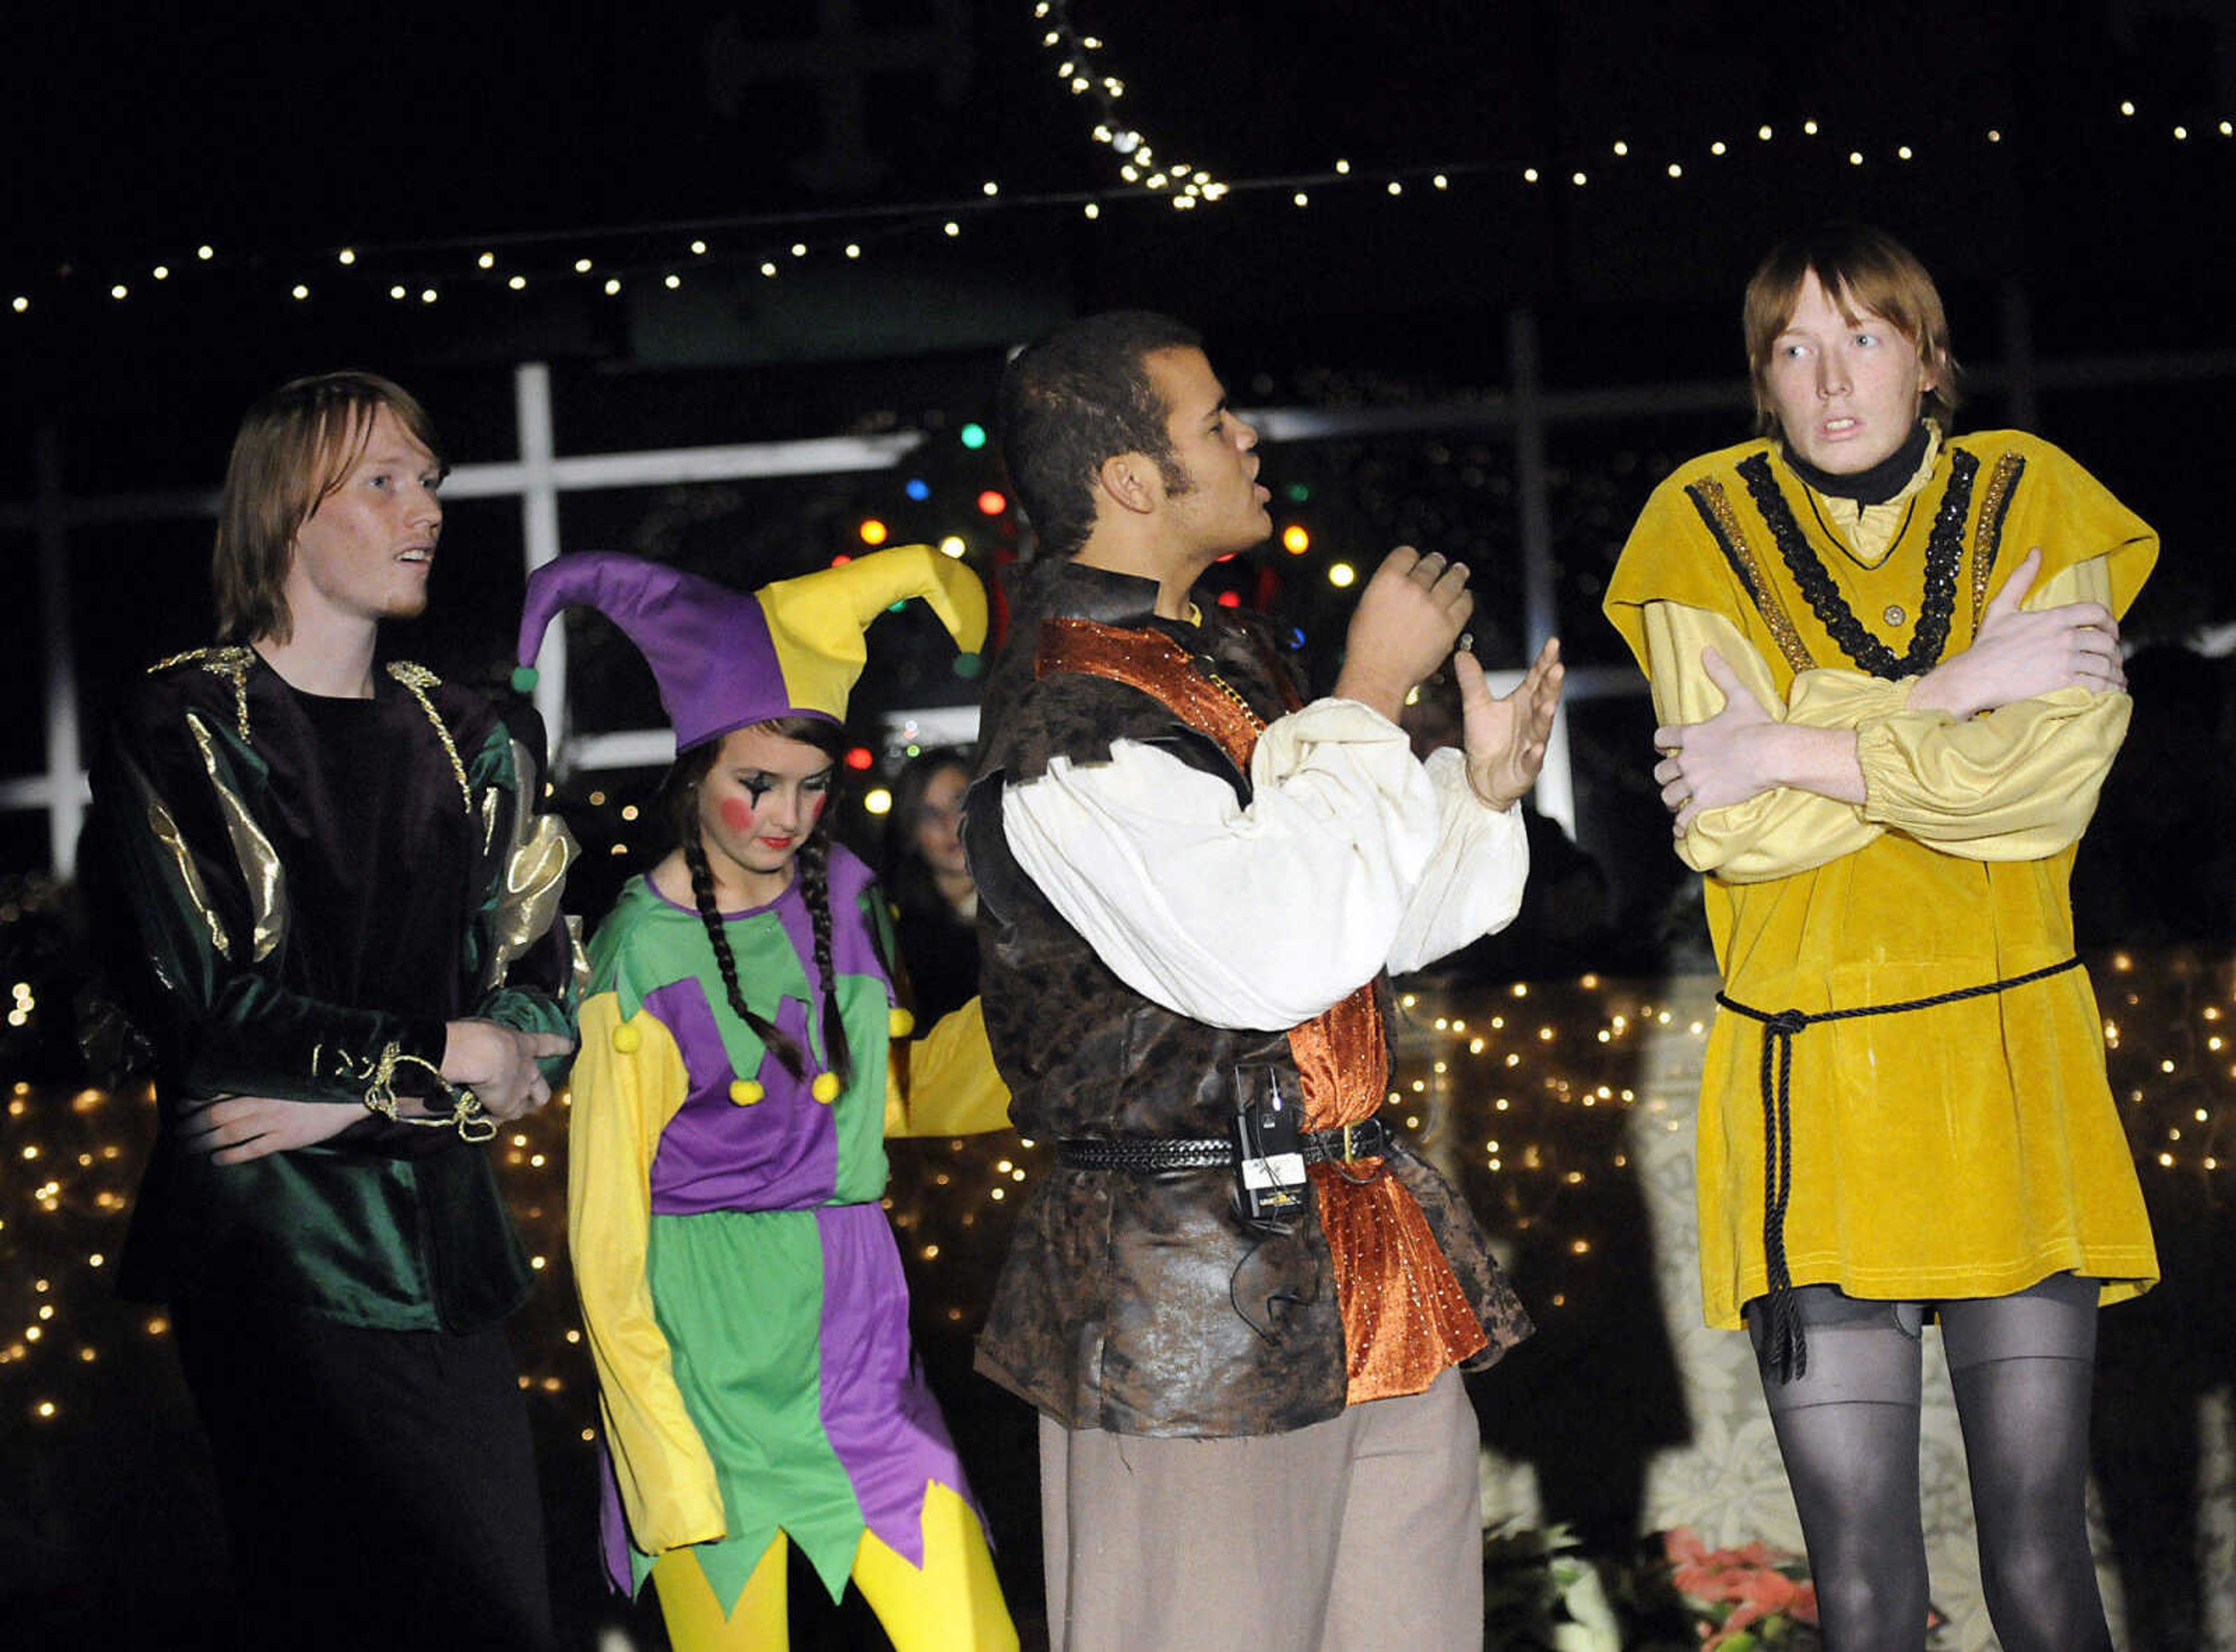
0;0;2236;338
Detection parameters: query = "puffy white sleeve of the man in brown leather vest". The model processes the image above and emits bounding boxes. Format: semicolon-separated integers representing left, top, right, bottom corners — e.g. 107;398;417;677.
1002;700;1527;1031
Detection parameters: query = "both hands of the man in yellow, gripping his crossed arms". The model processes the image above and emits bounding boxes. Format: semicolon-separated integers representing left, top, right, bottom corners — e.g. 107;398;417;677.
1655;548;2127;836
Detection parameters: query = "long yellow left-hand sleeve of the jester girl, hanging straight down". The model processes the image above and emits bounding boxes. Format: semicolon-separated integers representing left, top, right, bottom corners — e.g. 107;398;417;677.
566;993;727;1554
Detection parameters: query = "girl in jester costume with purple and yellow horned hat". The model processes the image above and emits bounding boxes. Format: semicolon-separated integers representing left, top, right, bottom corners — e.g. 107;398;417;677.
519;546;1017;1652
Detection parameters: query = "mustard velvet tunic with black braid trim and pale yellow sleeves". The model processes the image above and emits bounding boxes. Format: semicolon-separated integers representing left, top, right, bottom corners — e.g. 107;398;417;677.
1605;431;2158;1326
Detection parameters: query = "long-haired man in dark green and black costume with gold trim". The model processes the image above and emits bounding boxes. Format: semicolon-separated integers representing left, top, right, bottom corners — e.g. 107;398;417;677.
90;373;575;1647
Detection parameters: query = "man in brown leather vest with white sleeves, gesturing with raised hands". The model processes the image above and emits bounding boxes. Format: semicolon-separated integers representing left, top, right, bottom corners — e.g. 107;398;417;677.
964;313;1561;1652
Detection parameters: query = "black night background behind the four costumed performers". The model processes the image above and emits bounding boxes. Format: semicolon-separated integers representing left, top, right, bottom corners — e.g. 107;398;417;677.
0;0;2236;1645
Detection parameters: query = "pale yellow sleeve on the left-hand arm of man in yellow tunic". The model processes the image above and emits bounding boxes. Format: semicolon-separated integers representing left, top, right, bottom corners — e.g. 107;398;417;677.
1639;602;1909;883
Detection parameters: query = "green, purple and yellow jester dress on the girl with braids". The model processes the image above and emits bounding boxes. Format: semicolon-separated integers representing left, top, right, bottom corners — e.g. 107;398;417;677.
568;845;1006;1609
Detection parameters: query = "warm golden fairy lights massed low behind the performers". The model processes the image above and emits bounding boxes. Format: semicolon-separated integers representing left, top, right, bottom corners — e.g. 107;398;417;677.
0;948;2236;1442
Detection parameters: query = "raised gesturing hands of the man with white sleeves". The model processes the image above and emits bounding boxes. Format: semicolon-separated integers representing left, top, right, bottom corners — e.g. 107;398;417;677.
1335;546;1563;809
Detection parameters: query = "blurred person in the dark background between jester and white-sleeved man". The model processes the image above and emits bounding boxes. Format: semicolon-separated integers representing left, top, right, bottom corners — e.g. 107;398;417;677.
886;747;977;1020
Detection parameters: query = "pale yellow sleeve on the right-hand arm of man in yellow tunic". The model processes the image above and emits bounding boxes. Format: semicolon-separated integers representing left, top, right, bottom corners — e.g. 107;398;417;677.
1856;557;2131;861
